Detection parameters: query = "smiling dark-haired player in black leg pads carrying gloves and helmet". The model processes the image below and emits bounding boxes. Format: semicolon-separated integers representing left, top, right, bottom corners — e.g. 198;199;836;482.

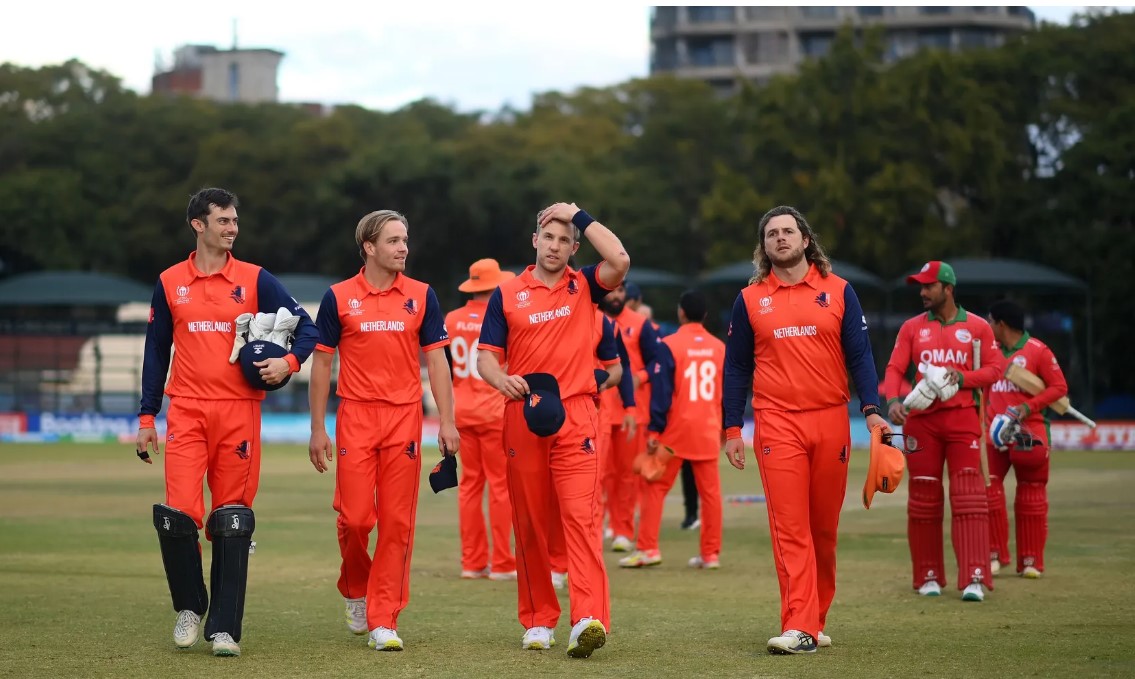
136;188;316;656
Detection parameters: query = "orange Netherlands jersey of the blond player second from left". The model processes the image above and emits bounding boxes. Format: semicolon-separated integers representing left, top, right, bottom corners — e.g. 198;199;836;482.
316;269;449;405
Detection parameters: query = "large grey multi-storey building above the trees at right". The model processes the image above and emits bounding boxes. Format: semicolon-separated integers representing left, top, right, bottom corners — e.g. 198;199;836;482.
650;7;1036;93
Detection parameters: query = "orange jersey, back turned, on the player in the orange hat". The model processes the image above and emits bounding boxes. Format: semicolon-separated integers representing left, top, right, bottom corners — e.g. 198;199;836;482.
445;300;505;427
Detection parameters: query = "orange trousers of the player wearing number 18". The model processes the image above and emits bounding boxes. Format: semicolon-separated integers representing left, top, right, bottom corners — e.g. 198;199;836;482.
637;455;722;561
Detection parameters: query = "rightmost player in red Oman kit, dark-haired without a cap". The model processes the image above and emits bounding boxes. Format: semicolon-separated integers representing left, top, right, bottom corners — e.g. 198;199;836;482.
984;300;1068;579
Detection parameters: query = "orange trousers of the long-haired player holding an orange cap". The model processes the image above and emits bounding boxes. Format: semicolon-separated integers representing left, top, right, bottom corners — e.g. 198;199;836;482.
753;404;851;637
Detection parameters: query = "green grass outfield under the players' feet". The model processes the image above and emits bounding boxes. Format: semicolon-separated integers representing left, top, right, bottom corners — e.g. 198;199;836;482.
0;444;1135;679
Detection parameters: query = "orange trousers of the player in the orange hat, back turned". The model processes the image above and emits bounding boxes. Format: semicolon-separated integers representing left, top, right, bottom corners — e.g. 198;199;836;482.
457;422;516;573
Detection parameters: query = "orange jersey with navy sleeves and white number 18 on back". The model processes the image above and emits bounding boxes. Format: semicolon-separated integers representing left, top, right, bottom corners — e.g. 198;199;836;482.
649;322;725;460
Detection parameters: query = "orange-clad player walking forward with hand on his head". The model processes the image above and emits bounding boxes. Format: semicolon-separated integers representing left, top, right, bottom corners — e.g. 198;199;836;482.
477;203;630;657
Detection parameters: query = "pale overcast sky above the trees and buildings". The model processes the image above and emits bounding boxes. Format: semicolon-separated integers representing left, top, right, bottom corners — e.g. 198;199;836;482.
0;0;1125;110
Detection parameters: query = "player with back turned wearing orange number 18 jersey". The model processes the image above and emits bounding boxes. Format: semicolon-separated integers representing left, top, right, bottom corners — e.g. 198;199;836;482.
619;291;725;569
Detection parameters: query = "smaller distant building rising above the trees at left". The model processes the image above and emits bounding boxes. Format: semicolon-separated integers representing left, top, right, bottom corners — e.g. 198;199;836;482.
151;44;284;103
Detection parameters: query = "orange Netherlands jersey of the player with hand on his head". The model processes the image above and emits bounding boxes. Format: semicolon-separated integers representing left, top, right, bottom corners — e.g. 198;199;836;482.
480;262;609;400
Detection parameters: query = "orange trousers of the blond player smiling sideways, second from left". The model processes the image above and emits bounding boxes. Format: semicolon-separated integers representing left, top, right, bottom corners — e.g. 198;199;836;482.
334;399;422;629
